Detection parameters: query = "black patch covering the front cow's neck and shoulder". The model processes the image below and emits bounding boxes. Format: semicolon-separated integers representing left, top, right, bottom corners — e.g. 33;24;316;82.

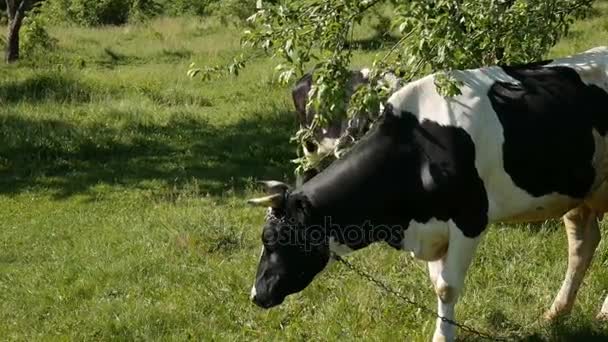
295;105;488;243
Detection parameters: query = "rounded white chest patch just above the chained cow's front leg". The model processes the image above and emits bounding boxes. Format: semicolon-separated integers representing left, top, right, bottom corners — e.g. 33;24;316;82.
401;218;449;261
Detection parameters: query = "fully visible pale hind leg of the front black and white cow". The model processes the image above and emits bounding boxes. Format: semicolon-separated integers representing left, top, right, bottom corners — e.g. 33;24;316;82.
545;206;600;320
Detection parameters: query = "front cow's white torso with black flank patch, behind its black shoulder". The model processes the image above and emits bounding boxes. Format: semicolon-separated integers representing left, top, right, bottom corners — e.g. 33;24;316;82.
389;48;608;221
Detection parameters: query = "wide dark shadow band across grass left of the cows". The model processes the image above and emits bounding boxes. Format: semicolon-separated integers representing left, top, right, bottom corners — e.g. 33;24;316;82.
0;110;295;198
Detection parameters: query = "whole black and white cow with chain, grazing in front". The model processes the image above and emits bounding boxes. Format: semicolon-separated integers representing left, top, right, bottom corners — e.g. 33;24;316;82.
250;47;608;341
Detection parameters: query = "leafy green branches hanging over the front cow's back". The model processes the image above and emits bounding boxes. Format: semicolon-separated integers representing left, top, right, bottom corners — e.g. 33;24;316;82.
189;0;593;176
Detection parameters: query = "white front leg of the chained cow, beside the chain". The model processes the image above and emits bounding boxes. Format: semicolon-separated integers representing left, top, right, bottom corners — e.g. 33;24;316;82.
429;224;480;342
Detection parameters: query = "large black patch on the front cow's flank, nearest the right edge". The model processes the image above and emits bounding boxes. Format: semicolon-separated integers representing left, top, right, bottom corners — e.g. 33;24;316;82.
488;65;608;198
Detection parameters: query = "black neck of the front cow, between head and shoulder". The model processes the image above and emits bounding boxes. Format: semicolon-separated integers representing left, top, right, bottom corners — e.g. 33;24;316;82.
300;112;423;252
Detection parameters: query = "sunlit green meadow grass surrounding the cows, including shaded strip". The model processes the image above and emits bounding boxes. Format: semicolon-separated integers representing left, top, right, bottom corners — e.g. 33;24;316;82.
0;2;608;341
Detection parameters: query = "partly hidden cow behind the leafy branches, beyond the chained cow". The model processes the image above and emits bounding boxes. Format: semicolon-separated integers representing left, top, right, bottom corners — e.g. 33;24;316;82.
291;68;401;185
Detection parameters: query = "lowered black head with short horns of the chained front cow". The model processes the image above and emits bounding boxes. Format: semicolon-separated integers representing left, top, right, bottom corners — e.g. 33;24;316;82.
248;181;330;308
